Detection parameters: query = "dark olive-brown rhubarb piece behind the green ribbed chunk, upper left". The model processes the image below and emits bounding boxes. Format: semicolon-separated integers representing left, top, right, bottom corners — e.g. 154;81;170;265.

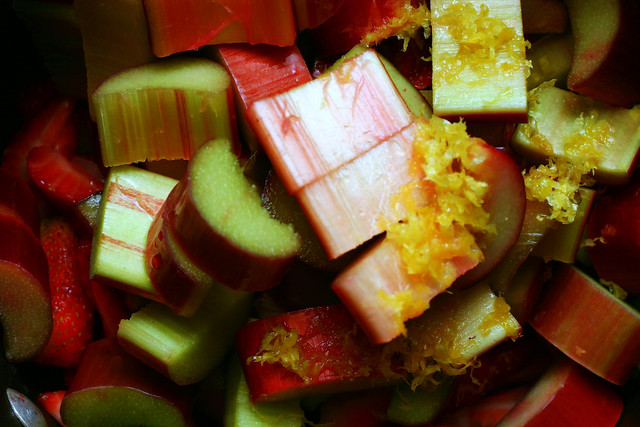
74;0;156;117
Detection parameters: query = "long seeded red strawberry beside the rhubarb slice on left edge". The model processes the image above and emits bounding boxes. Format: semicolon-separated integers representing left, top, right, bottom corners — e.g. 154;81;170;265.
36;218;94;367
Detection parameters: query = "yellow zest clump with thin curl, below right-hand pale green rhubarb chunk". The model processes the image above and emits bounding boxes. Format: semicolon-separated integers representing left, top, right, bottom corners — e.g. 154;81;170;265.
522;82;614;224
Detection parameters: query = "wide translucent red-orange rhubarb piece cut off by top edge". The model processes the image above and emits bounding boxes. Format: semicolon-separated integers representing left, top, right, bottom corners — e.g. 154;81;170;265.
143;0;297;57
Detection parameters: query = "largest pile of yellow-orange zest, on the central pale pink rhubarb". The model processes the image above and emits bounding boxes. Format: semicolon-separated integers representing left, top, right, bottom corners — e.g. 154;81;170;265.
386;117;496;287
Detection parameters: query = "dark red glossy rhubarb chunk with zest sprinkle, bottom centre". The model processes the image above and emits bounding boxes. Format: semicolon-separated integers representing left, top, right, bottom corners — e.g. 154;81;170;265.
235;305;402;403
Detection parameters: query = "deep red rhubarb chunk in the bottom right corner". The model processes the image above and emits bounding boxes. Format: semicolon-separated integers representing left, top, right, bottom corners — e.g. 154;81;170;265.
498;359;622;427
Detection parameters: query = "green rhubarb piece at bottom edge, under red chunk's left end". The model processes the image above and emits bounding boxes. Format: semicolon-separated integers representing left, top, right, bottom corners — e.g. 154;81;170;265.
224;356;304;427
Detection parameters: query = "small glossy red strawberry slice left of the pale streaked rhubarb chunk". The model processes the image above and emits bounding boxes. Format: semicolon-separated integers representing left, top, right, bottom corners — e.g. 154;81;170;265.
27;146;104;206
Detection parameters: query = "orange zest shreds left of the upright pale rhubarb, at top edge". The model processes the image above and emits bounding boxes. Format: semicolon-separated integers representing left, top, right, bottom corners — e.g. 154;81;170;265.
361;0;431;50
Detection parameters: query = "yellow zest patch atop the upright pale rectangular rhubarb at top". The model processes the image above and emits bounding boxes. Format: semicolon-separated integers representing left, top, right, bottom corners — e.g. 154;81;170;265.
432;1;531;84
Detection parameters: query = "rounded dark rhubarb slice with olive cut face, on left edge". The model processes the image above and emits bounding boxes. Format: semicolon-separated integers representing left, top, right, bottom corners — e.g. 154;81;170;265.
0;215;53;363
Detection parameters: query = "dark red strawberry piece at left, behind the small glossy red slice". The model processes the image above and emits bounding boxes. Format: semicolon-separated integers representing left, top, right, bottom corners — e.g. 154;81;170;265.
2;96;77;181
